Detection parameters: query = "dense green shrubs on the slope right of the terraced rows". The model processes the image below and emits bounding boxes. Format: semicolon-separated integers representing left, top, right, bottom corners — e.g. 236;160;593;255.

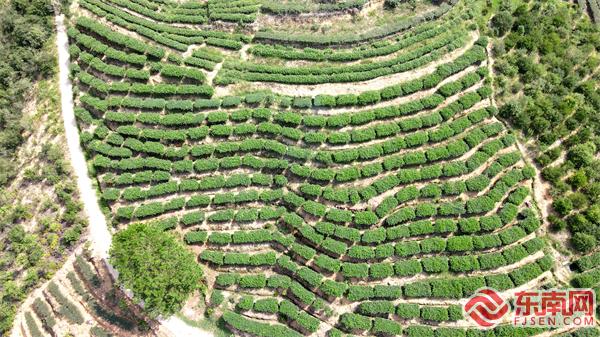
492;1;600;253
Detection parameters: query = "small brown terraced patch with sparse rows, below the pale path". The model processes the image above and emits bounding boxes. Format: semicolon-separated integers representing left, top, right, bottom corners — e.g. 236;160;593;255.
13;251;157;337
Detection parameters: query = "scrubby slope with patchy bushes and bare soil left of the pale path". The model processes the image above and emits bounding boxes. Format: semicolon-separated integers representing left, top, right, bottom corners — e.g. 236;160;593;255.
0;0;86;334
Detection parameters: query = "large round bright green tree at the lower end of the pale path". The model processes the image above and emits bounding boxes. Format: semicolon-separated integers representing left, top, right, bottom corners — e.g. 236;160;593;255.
110;224;203;317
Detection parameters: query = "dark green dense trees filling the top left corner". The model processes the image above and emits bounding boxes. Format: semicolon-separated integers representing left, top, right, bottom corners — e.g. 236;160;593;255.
0;0;62;186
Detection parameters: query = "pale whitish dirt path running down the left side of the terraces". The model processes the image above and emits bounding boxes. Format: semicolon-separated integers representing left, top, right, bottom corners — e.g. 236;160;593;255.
53;15;213;337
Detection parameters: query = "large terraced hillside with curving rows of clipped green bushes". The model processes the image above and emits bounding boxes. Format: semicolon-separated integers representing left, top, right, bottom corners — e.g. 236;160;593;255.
61;0;596;337
